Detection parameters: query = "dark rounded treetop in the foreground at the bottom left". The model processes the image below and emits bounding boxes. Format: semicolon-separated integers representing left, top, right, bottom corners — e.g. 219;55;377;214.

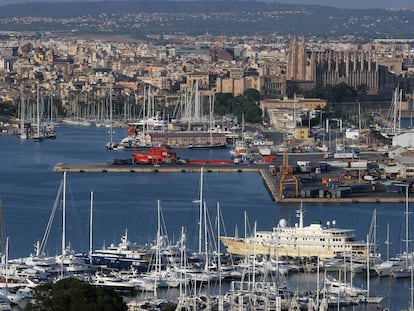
26;278;127;311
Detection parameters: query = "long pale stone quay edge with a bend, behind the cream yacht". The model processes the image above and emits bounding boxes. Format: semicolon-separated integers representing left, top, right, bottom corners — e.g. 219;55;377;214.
53;163;414;204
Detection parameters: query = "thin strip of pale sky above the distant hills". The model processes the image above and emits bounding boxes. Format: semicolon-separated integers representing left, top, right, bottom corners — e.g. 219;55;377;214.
0;0;414;9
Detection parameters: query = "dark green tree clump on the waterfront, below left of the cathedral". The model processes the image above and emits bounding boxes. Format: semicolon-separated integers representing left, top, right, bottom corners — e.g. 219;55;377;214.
215;89;262;123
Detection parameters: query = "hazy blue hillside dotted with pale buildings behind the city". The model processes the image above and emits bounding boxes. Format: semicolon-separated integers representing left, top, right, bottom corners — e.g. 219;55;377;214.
0;0;414;40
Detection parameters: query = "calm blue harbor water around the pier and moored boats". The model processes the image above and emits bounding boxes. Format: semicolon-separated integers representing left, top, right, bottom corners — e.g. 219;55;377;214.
0;126;414;310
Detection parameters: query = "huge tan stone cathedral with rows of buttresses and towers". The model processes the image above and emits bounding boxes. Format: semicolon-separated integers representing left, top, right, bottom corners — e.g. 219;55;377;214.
287;37;387;94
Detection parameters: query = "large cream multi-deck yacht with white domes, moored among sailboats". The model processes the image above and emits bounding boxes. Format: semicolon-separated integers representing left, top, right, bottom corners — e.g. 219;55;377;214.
221;206;367;260
